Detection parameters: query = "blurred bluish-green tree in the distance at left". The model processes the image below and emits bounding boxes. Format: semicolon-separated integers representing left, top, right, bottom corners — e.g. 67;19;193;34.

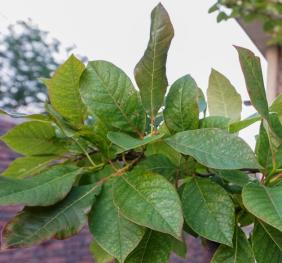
0;20;66;110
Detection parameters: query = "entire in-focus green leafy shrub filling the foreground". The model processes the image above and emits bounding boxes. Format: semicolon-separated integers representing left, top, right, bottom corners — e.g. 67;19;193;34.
0;4;282;263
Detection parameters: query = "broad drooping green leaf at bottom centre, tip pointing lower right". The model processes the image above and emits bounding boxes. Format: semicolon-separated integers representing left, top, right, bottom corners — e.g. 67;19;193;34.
113;169;183;238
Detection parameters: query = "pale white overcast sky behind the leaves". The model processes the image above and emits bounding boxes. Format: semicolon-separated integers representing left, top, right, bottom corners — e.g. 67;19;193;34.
0;0;266;146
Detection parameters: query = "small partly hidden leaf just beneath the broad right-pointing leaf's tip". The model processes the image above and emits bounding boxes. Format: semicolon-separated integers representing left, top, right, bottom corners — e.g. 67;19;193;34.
215;170;251;186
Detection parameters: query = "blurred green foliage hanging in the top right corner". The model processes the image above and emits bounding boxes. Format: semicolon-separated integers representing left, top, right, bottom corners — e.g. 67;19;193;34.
209;0;282;45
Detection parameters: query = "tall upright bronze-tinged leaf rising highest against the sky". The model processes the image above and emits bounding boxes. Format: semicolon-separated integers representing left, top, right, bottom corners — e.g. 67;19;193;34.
134;4;174;120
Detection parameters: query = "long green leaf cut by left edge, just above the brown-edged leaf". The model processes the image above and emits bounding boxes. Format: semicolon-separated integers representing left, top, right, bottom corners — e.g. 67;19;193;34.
0;165;80;206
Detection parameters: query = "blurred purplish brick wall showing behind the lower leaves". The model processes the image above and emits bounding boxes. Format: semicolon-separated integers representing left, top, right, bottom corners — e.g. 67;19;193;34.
0;117;214;263
